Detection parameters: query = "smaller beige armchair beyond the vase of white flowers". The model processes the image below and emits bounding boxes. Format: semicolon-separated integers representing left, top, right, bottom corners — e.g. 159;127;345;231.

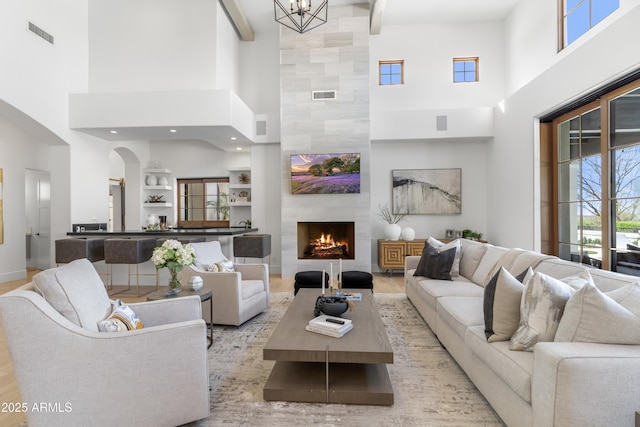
180;241;269;326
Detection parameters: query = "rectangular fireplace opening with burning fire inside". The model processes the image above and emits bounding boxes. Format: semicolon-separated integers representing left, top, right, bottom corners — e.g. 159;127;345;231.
298;222;355;259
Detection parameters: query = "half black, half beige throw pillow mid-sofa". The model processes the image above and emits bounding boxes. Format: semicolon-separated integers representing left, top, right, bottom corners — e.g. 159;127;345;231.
483;267;533;342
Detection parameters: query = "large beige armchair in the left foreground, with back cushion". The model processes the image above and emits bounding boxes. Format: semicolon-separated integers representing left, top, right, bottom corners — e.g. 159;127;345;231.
0;259;209;427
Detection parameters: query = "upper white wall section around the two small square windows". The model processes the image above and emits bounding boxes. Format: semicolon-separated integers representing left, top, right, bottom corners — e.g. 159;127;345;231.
370;22;504;112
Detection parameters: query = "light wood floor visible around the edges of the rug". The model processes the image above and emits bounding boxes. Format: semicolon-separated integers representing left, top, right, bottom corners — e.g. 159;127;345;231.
0;270;404;427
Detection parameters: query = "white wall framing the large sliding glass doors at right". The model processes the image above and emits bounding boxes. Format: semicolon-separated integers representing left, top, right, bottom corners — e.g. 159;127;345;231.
487;0;640;250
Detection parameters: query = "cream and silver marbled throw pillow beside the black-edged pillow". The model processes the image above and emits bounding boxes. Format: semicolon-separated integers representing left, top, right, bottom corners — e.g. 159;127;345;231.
509;272;577;351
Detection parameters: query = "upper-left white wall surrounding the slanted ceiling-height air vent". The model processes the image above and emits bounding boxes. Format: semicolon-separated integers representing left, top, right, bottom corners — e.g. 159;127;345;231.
0;0;88;138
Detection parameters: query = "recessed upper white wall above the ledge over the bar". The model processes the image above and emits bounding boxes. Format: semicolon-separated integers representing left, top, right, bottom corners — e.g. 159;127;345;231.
87;0;218;92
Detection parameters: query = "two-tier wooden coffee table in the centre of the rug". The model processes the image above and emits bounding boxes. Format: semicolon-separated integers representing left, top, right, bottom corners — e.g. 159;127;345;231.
263;289;393;405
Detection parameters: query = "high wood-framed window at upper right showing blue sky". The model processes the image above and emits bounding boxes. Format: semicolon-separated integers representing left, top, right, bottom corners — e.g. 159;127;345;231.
559;0;620;49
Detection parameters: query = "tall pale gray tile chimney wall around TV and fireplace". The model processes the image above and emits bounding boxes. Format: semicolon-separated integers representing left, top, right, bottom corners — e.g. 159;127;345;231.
280;3;372;277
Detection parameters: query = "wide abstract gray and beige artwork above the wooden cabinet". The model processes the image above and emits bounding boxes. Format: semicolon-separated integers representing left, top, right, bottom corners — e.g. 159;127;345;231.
391;169;462;215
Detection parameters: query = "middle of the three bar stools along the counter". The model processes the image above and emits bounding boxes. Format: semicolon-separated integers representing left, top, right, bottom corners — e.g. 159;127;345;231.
104;237;156;296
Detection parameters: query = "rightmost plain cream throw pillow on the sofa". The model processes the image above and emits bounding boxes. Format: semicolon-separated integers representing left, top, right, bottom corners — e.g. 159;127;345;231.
554;282;640;344
